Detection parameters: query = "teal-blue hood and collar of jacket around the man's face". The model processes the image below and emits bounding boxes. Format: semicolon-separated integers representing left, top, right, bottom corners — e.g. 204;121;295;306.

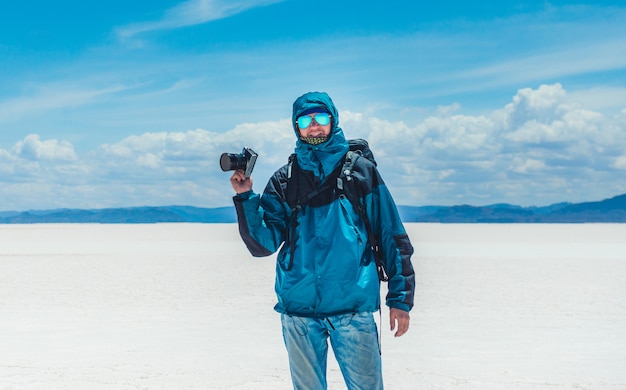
291;92;349;181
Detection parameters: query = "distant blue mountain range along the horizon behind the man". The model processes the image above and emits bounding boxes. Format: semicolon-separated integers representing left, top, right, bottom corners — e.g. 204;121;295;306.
0;194;626;224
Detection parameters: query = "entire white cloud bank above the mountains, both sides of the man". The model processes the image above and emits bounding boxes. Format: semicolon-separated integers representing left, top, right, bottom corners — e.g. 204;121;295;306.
0;84;626;209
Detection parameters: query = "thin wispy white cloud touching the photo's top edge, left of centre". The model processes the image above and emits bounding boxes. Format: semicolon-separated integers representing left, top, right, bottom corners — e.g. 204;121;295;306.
116;0;284;40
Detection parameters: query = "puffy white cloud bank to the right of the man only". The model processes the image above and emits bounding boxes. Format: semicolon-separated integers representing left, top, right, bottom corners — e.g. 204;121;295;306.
344;84;626;205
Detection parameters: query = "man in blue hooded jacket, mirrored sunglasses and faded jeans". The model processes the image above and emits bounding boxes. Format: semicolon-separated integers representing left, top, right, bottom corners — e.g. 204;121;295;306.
231;92;415;390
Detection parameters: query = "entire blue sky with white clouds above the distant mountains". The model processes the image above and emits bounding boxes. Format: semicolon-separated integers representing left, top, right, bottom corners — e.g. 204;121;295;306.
0;0;626;210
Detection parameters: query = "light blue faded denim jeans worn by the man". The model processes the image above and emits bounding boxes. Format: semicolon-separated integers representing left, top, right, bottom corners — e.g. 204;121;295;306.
281;313;383;390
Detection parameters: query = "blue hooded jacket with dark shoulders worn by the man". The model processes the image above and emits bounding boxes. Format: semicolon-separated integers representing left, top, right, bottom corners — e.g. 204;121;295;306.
234;92;415;318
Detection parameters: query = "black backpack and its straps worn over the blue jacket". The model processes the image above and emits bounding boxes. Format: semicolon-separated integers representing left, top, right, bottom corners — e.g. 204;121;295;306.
285;138;389;282
